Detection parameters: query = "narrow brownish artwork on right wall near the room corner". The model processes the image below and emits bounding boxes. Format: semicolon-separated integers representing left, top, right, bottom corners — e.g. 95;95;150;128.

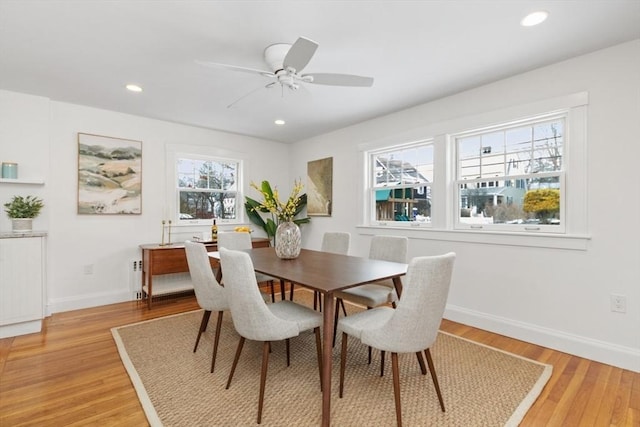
307;157;333;216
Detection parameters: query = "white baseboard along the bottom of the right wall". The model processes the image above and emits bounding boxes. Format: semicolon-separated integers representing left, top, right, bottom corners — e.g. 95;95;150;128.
444;304;640;372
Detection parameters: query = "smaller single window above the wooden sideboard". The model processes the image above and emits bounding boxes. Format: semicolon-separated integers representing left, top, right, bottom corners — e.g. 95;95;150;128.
175;154;243;224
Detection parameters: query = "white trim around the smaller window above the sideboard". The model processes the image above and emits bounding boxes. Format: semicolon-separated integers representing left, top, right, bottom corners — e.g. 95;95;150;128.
163;144;245;227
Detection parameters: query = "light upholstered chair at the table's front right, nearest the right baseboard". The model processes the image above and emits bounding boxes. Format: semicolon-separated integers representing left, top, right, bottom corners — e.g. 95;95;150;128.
338;252;455;426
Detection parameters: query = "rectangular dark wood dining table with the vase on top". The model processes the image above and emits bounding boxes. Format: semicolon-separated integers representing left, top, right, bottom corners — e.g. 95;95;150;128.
209;247;407;427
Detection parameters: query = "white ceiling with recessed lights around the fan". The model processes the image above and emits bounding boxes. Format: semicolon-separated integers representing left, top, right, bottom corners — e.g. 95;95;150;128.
0;0;640;142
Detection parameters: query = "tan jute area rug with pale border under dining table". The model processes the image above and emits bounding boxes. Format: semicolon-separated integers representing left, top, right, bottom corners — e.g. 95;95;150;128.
112;291;552;427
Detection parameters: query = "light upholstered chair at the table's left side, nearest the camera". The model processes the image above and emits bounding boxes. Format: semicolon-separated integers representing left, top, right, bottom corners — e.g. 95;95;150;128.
220;247;322;424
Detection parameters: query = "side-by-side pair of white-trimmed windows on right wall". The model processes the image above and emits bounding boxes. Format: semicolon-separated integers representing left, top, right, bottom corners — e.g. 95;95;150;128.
358;92;590;250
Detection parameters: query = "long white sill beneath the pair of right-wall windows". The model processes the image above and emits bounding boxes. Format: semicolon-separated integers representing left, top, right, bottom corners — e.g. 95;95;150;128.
356;225;591;251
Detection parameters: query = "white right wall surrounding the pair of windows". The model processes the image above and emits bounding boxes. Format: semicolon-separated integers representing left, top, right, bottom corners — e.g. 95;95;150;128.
292;40;640;371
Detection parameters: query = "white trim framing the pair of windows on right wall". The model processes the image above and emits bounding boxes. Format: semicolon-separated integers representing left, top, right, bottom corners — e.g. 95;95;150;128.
357;92;591;250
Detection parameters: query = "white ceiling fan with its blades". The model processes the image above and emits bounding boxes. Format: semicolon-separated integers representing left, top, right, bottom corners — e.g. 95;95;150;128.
196;37;373;108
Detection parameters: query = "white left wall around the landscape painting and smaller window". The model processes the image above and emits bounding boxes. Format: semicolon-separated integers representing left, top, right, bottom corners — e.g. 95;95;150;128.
0;91;290;313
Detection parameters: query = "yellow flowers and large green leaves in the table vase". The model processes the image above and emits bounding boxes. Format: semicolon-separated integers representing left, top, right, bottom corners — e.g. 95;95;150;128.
244;180;310;256
